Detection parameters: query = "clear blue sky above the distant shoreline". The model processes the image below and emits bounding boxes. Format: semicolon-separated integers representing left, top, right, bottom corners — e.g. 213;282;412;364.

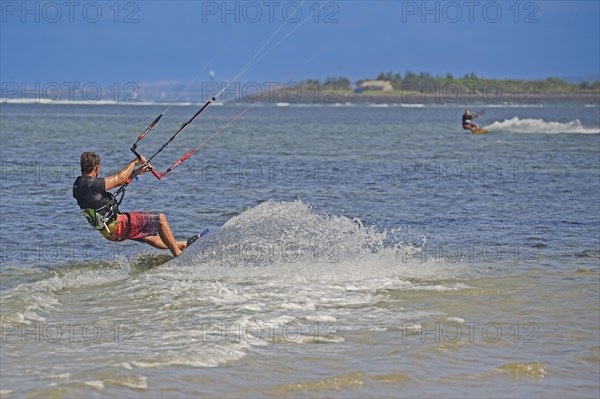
0;0;600;85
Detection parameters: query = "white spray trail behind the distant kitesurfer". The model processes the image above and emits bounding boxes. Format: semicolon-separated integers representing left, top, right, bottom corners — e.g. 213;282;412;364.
485;116;600;134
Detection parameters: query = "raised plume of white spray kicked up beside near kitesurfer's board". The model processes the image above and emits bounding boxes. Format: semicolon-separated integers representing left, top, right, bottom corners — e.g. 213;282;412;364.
170;201;465;284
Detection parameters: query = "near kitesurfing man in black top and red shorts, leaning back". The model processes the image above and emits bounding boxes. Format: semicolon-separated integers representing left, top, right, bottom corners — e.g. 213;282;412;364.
73;152;200;256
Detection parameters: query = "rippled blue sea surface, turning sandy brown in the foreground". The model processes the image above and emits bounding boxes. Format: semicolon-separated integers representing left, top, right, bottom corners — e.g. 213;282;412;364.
0;103;600;398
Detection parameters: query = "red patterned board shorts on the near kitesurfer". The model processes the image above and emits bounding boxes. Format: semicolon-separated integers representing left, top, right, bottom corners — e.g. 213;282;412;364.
106;212;160;241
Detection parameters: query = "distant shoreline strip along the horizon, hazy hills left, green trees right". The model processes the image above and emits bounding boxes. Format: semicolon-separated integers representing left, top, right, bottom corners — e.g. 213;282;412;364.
0;71;600;104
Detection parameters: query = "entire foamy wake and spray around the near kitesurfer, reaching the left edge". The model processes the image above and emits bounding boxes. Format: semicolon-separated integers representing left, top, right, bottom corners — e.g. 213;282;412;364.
2;201;468;376
